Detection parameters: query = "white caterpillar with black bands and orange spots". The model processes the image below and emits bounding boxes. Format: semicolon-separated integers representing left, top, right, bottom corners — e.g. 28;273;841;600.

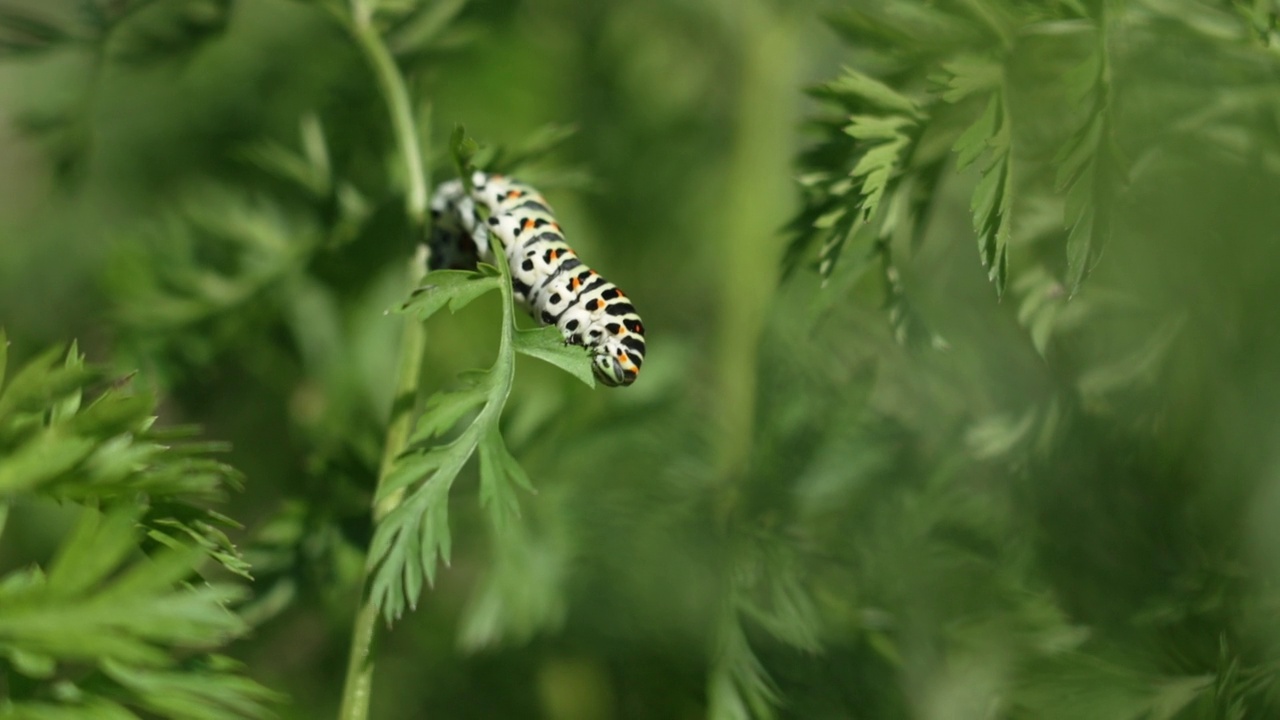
429;172;645;387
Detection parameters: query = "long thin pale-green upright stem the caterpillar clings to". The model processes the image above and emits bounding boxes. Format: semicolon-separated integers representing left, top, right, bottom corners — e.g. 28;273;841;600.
338;0;428;720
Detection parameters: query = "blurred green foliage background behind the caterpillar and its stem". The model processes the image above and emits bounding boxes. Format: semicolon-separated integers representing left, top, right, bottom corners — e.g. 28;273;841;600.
0;0;1280;720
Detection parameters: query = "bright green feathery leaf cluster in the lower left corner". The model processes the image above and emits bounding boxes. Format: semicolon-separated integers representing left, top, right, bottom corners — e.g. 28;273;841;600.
0;336;275;720
